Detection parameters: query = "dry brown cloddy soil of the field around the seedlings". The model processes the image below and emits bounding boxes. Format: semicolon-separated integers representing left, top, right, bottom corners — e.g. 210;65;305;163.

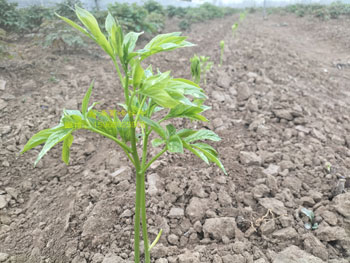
0;11;350;263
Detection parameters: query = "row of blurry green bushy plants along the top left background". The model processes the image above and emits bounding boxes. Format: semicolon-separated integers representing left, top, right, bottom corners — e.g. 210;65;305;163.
0;0;236;34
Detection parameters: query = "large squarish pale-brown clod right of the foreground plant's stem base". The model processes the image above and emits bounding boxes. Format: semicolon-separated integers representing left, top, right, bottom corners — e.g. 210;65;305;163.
203;217;236;241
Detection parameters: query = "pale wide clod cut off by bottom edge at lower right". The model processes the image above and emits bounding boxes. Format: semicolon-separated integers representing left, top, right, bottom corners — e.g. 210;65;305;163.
272;246;325;263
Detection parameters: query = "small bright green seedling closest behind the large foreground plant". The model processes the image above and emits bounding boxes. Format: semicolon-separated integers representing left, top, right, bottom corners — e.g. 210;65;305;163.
190;55;214;85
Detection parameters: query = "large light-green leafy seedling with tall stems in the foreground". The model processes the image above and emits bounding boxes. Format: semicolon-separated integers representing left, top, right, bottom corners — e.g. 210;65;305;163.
22;6;226;263
